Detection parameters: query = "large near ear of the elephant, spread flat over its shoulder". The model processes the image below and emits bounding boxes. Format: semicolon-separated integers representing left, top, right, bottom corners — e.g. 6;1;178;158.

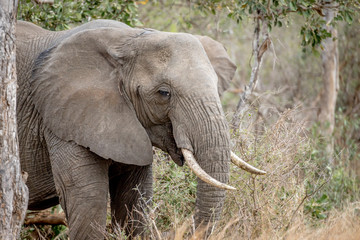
30;28;152;166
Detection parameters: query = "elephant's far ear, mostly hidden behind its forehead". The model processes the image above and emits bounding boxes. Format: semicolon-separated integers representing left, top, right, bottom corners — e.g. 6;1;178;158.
196;35;236;96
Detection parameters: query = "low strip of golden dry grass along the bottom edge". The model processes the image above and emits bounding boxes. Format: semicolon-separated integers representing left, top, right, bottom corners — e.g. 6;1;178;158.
113;202;360;240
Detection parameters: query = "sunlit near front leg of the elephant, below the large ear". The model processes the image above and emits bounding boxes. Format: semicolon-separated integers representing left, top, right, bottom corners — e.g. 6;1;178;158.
45;133;111;240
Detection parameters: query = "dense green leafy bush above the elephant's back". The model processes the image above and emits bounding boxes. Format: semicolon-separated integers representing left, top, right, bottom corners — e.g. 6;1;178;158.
18;0;141;31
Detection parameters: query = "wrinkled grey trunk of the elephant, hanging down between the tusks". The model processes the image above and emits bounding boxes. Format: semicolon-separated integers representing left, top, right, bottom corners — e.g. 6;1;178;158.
171;98;230;226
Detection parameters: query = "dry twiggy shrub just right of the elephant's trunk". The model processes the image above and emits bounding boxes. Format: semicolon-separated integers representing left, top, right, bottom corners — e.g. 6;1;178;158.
219;110;317;239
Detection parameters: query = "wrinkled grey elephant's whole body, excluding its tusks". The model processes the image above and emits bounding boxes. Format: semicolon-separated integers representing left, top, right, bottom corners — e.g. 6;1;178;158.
16;20;235;240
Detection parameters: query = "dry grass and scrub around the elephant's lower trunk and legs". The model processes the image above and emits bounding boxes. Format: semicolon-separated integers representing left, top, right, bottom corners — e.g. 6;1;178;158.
21;110;360;239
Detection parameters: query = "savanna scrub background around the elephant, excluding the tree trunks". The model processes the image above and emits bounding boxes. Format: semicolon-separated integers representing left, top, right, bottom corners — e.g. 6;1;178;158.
18;0;360;239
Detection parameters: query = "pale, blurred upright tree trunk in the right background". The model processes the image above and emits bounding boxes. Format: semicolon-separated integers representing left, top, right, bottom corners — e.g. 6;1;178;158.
318;0;339;165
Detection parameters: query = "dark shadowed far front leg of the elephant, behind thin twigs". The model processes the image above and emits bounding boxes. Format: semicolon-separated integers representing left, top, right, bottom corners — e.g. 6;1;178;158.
109;163;153;237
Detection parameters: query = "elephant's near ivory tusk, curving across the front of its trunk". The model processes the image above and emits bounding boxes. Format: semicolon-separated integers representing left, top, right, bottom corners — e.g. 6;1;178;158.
181;148;236;190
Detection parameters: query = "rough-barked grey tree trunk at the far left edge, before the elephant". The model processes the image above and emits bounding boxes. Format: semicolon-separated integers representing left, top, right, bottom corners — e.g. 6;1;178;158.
0;0;28;240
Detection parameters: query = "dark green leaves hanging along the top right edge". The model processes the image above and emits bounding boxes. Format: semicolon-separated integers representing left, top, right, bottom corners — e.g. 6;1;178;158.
195;0;360;47
